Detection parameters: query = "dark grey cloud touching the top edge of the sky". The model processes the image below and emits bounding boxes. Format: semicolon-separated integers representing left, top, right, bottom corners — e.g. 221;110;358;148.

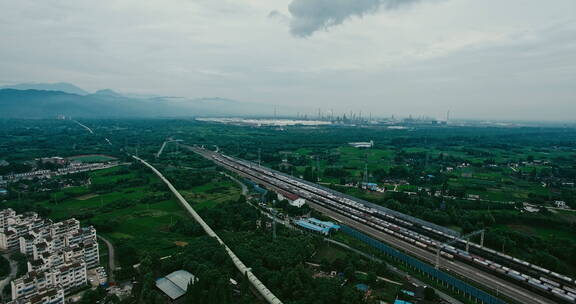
288;0;420;37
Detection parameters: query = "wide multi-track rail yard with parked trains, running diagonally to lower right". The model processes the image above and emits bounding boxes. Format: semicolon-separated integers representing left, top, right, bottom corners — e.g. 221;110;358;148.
188;147;576;303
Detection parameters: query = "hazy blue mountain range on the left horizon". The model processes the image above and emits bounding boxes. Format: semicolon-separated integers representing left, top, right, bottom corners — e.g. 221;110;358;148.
0;89;280;118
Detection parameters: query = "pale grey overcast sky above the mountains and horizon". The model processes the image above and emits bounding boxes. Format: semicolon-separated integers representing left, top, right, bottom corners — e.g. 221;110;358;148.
0;0;576;121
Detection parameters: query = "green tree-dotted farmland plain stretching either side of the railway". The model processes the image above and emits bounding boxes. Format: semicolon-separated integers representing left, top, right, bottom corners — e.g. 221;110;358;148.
0;120;576;303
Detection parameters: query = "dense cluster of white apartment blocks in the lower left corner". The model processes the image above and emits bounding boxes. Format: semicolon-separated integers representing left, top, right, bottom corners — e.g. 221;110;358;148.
0;209;100;304
